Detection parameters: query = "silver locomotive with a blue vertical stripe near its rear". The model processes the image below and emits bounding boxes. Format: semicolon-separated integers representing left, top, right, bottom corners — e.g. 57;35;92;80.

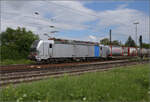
29;39;109;61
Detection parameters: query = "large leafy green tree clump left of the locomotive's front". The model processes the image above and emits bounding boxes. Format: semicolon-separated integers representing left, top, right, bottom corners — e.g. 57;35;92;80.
0;27;39;59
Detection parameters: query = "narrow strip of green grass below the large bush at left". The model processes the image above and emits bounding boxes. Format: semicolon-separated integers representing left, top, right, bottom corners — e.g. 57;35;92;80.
0;59;34;65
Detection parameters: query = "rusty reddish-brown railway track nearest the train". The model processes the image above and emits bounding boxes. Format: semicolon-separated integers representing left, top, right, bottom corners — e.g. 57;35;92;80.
0;56;136;73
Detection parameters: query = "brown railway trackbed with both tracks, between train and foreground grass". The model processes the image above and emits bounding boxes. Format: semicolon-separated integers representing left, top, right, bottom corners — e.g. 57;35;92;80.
0;59;147;86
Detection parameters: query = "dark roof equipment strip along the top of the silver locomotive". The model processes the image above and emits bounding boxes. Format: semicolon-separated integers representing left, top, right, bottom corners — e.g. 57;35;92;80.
48;38;99;45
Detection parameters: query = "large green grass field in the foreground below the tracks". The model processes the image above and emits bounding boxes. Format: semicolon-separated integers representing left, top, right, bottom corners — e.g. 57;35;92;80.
0;64;150;102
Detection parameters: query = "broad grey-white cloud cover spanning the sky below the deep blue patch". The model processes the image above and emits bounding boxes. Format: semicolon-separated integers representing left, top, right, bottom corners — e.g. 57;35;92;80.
1;0;149;41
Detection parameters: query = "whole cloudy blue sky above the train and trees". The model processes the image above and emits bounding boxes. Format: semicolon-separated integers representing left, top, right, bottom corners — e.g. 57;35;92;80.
0;0;150;43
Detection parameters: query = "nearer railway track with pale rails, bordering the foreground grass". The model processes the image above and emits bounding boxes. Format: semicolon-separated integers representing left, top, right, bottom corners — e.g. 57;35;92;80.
0;60;147;86
